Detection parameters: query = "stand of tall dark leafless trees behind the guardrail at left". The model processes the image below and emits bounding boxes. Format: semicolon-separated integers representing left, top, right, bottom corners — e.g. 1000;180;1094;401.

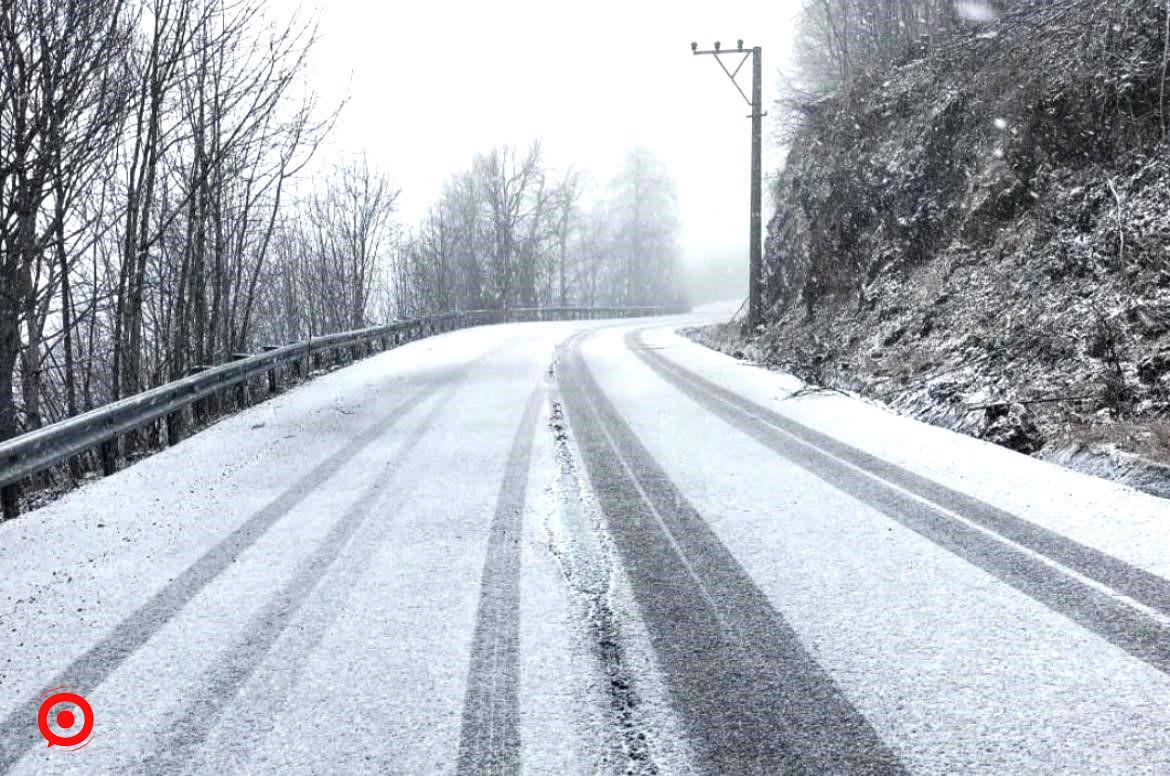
0;0;339;514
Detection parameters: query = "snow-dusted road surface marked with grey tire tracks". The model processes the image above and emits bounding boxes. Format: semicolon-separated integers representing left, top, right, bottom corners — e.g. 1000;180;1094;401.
0;315;1170;774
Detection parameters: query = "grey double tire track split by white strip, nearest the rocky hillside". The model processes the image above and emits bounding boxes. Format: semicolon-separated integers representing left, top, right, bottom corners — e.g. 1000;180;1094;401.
625;330;1170;673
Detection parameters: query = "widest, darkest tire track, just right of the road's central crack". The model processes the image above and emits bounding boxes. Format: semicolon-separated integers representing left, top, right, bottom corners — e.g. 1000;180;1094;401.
560;330;904;775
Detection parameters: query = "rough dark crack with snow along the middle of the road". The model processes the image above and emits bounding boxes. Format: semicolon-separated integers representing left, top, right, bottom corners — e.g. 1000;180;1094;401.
544;397;660;776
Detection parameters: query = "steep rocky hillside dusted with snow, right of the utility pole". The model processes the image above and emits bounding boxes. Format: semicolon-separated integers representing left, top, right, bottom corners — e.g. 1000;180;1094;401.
732;0;1170;495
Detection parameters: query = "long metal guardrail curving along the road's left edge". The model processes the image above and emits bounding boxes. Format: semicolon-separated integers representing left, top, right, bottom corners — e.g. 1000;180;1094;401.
0;307;686;514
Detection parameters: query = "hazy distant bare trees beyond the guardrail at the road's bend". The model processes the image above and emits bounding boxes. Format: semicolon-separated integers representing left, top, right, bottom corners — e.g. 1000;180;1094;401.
394;143;681;315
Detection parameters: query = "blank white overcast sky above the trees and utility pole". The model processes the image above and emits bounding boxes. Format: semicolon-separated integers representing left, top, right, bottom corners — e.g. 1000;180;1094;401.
273;0;798;272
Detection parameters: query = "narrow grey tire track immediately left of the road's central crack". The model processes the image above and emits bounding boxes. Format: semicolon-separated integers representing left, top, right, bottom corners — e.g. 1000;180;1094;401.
455;385;544;775
